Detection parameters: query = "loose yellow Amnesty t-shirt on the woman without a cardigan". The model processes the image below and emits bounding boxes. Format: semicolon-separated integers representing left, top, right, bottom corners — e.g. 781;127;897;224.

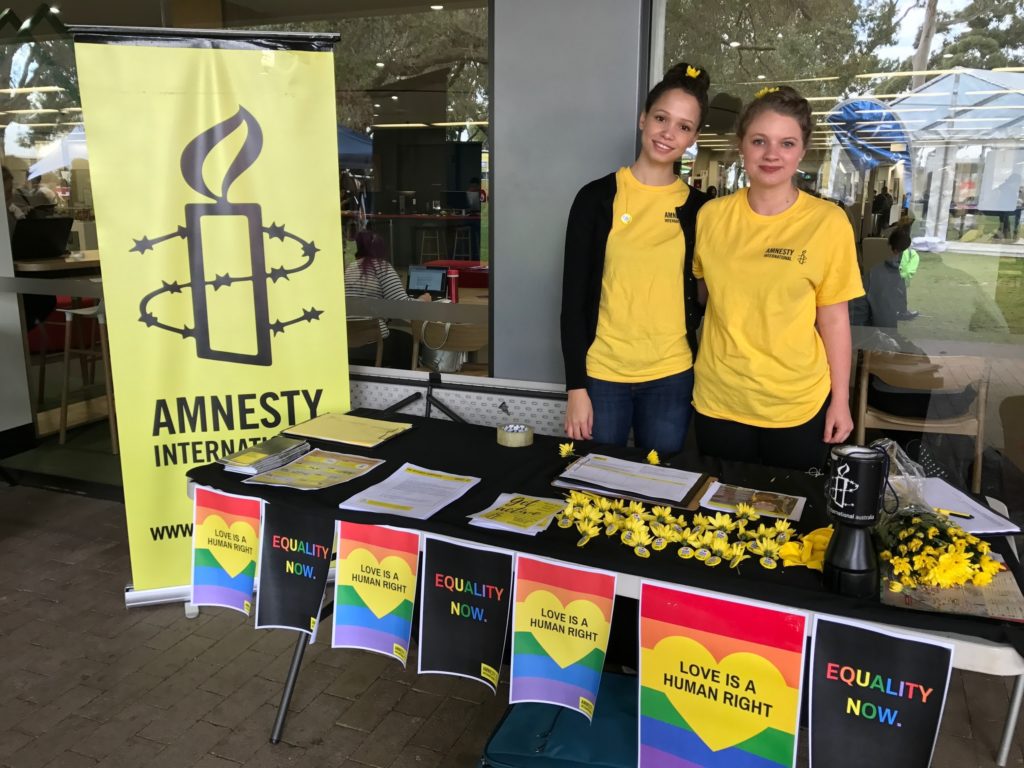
693;189;864;427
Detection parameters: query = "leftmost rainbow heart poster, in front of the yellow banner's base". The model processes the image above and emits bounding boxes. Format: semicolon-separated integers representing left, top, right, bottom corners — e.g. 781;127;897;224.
191;487;263;615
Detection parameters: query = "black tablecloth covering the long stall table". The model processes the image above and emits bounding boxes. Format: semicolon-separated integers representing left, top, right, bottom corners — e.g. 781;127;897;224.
188;411;1024;654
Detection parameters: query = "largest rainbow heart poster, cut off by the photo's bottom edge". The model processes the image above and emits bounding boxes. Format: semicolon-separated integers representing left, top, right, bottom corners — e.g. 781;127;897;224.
639;583;807;768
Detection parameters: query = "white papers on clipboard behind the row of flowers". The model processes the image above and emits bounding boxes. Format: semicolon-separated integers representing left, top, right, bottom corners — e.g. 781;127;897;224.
555;454;702;503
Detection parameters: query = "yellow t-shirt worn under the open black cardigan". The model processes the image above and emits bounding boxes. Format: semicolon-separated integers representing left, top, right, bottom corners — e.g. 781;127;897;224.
587;168;693;383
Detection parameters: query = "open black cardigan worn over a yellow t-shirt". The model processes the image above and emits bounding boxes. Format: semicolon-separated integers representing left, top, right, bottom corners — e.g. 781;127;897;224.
561;173;709;389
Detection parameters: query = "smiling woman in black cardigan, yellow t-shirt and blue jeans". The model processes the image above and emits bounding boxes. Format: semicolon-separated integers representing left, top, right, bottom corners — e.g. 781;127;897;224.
561;62;711;454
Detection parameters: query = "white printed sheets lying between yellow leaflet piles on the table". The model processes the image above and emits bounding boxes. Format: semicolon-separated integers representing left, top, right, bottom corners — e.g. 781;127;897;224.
338;462;480;520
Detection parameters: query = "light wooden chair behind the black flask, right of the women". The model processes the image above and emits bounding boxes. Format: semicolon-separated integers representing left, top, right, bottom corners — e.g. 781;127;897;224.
854;349;988;494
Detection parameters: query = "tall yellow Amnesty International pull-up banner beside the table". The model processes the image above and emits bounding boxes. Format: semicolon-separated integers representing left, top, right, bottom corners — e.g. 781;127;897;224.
75;37;348;590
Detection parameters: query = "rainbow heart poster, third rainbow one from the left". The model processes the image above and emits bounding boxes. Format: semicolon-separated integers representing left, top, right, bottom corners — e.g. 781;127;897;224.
509;555;615;719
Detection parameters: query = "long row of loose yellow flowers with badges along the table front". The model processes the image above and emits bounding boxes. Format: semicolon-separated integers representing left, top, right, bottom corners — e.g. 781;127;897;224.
556;490;793;568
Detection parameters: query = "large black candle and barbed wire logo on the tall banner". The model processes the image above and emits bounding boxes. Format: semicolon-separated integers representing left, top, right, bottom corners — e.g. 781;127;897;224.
130;106;324;366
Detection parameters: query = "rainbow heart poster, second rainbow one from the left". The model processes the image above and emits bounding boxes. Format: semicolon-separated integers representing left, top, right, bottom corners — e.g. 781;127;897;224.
331;520;420;666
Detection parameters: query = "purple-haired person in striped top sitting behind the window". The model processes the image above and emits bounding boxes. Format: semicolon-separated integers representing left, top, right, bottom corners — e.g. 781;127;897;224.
345;229;430;368
